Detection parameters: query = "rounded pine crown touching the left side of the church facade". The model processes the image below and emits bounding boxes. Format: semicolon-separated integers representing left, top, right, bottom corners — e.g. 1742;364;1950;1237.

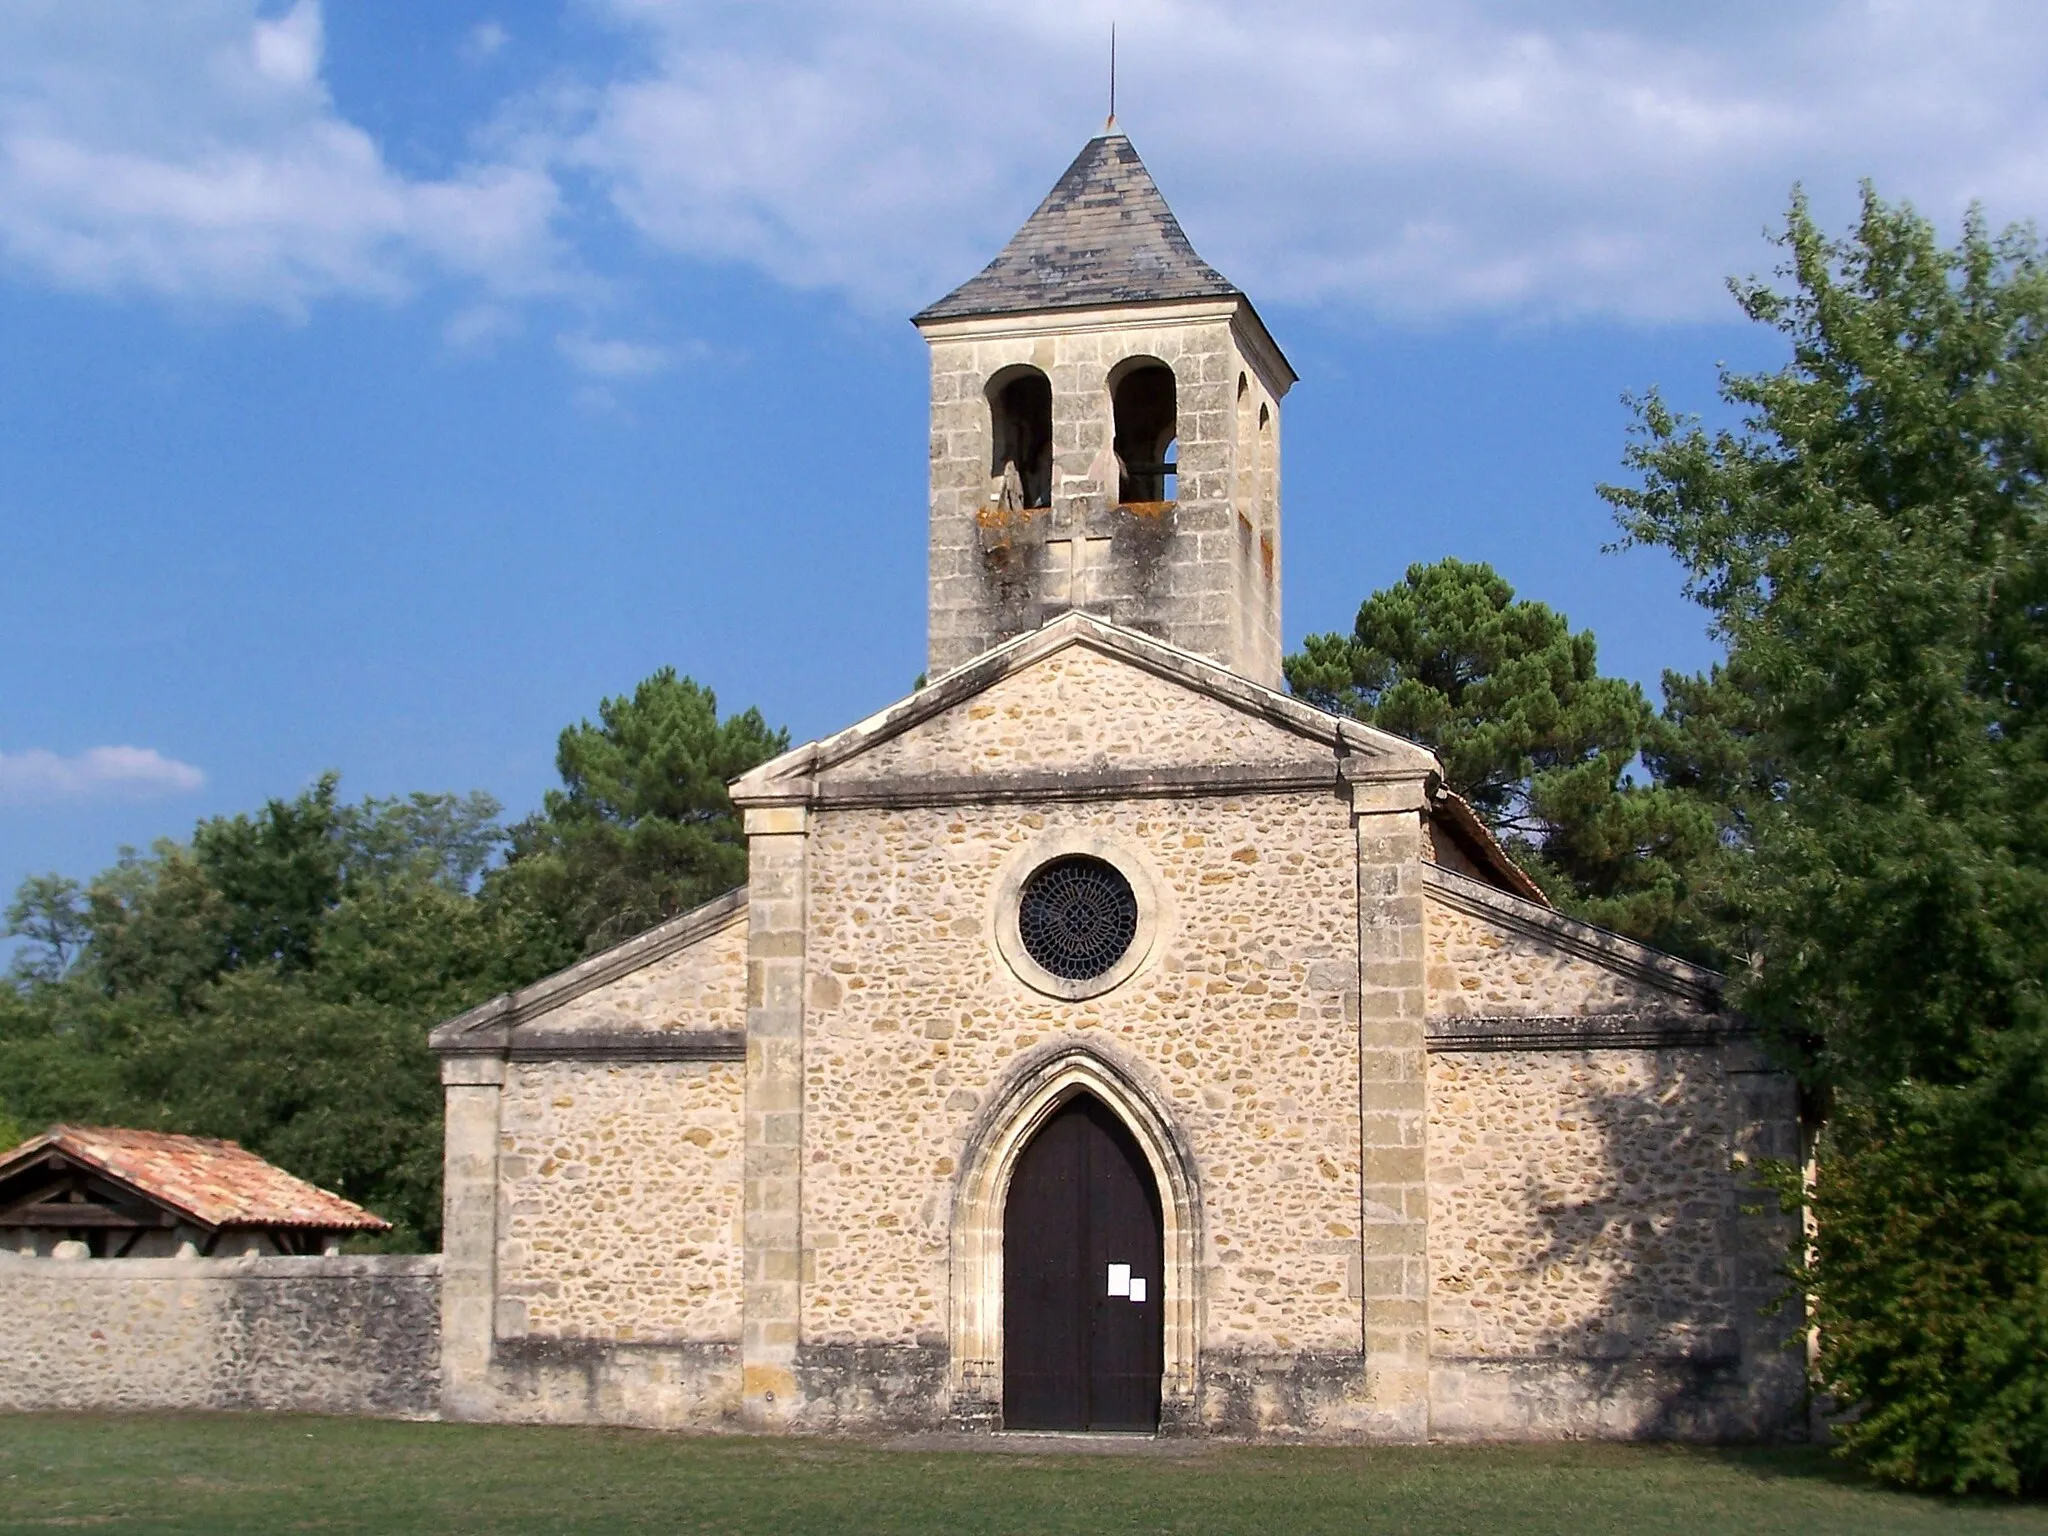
500;668;788;950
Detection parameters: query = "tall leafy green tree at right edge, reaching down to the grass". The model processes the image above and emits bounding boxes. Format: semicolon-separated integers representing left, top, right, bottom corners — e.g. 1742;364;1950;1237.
1606;188;2048;1489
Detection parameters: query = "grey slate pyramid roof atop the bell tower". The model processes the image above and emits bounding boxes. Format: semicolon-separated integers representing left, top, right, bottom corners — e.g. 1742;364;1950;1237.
915;133;1239;322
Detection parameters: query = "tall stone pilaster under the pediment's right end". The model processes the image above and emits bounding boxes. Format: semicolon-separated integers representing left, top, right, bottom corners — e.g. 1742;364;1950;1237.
1346;760;1430;1440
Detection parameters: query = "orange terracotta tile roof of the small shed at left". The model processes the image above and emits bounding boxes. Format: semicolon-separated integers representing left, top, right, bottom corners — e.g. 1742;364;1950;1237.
0;1124;391;1231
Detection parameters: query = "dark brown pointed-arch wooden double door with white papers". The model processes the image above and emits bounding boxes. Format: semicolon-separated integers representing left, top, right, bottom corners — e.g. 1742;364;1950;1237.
1004;1094;1165;1432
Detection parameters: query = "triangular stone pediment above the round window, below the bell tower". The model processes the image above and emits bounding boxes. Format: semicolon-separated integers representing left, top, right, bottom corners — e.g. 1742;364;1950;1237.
733;612;1438;805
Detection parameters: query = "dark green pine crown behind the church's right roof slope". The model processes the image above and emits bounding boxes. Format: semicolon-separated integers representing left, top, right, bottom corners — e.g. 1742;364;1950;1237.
1286;559;1718;950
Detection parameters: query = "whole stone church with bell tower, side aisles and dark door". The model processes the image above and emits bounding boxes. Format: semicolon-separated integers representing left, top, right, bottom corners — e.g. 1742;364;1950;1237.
432;123;1802;1442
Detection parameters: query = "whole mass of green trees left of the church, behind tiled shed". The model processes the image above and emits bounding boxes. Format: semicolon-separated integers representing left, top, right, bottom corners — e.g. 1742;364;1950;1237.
0;670;786;1247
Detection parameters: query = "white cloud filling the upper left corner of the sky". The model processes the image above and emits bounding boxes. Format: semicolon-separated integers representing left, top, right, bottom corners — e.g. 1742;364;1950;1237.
0;0;559;311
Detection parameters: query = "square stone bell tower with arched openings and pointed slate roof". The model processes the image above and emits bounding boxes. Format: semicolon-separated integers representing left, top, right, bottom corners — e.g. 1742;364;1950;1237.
913;129;1294;686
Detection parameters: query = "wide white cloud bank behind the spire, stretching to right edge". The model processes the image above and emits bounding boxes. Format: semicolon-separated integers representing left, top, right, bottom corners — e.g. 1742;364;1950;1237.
565;0;2048;319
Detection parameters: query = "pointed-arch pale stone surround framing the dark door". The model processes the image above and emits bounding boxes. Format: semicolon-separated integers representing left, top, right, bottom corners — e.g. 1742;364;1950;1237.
946;1038;1202;1427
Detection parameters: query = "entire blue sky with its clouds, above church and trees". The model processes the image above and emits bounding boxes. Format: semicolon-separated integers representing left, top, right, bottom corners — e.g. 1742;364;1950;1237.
0;0;2048;913
